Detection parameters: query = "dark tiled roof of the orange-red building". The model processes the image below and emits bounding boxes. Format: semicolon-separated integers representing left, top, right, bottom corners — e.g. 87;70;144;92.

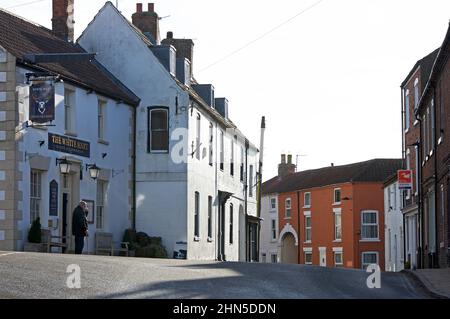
262;159;402;194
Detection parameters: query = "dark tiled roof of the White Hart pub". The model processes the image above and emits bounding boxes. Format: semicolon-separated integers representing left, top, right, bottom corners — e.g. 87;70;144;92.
0;9;140;106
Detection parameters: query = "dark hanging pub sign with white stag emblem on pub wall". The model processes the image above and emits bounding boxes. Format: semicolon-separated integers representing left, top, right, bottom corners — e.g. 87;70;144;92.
29;80;55;123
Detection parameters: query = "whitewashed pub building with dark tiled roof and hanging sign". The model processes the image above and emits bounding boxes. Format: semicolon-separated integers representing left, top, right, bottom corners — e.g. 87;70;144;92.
0;8;140;253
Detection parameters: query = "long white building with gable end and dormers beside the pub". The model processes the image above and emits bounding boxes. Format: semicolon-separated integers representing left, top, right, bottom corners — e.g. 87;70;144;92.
78;2;259;261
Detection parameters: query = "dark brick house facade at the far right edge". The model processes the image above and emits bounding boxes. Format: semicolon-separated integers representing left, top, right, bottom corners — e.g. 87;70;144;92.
415;22;450;268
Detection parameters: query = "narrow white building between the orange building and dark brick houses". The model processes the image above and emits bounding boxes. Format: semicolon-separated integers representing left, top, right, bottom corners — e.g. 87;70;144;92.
384;176;405;272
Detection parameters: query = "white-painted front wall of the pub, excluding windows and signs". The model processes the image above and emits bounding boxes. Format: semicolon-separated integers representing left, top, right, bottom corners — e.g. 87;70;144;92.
18;68;132;253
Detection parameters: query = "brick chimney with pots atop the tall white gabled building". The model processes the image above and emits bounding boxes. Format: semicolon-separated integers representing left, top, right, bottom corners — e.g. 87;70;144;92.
131;3;161;45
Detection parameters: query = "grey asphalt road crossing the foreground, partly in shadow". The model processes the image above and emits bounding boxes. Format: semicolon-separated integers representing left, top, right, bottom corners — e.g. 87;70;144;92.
0;252;427;299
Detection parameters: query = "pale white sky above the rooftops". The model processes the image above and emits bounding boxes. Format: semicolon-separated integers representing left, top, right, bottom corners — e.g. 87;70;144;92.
0;0;450;180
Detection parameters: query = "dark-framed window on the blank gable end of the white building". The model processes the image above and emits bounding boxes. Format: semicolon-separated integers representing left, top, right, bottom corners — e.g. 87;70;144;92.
149;109;169;152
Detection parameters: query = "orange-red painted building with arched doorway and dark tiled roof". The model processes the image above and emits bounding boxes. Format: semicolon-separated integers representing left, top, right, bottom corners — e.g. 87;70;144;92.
263;159;402;269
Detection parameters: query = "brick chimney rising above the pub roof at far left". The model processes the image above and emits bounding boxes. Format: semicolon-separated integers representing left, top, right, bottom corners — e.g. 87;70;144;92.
52;0;75;42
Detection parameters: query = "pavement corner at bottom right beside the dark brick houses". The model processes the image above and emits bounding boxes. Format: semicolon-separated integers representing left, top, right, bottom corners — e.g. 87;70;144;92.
405;268;450;299
